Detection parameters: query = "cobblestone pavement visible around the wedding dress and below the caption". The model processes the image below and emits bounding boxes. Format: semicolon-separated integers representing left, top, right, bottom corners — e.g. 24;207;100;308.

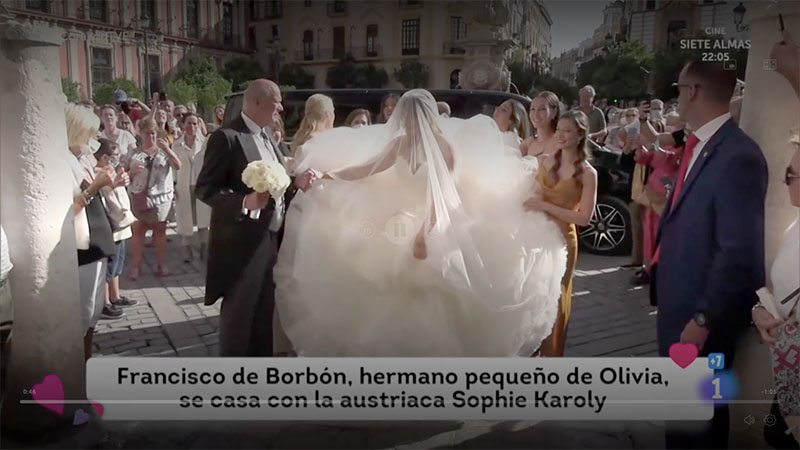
45;230;663;449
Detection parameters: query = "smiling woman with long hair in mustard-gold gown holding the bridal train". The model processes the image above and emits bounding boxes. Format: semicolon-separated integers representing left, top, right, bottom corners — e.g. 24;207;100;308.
524;111;597;356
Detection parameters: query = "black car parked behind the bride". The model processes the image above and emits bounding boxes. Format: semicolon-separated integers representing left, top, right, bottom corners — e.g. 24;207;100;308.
225;89;632;255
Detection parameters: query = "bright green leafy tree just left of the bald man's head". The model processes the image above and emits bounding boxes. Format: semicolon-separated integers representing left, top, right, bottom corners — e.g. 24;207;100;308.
167;58;231;114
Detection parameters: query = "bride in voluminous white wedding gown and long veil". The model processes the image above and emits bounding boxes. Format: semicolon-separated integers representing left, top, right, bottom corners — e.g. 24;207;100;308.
274;89;566;356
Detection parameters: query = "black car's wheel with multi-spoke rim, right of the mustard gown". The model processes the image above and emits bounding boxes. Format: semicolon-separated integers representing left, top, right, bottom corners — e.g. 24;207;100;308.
578;195;632;255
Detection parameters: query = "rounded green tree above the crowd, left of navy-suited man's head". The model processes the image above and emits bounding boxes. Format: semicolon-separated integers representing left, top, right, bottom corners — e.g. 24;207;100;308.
577;42;653;98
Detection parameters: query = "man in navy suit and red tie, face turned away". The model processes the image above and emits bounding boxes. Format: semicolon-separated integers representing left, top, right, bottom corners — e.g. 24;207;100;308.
650;61;767;448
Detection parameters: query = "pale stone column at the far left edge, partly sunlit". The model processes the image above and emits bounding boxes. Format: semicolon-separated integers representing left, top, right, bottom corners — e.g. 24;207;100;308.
0;15;91;432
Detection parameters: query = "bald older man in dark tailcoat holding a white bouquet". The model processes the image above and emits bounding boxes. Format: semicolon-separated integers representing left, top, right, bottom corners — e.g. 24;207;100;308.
196;79;312;356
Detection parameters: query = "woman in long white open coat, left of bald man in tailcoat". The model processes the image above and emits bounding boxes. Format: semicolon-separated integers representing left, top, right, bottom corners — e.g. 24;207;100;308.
172;113;211;263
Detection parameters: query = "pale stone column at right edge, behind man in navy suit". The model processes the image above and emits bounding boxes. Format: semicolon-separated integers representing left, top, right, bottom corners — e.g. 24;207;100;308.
740;2;800;270
